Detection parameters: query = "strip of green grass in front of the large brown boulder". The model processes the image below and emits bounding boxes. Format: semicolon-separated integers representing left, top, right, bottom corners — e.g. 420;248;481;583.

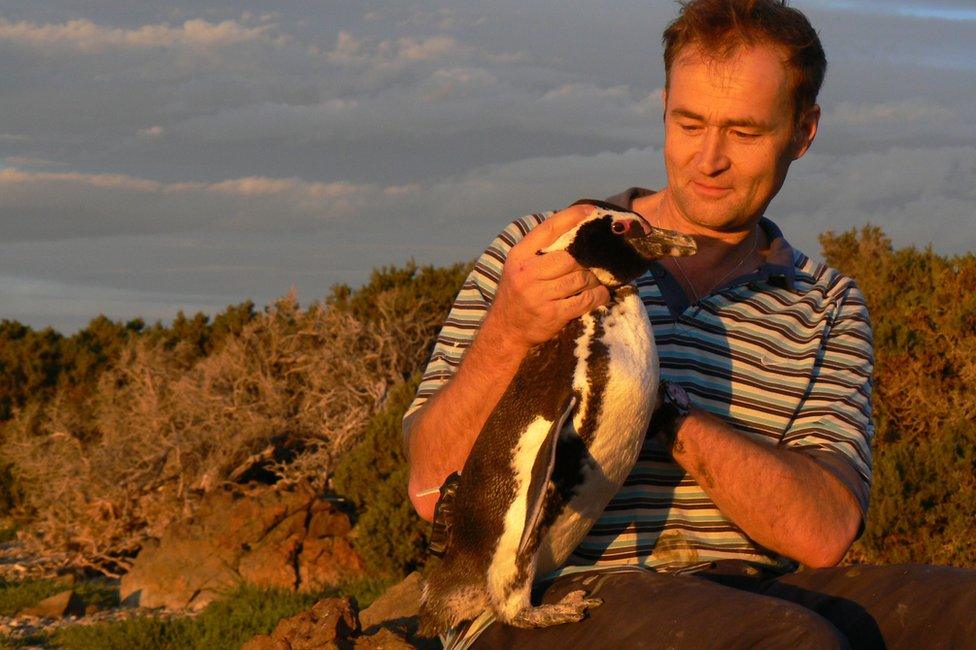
51;579;390;650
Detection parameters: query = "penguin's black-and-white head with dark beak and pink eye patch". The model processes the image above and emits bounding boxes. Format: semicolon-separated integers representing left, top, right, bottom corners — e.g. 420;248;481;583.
539;201;697;288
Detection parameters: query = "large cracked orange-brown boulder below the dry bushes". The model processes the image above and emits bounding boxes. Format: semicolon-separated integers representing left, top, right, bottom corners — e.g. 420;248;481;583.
120;484;365;610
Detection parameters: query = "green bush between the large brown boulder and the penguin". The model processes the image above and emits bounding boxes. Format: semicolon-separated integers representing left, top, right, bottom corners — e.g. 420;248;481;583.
334;376;428;576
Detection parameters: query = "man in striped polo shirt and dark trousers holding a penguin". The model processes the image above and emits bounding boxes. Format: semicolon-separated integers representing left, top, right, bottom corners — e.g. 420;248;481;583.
404;0;976;648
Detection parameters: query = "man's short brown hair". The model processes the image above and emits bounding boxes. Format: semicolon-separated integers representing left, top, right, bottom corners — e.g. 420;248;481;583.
663;0;827;116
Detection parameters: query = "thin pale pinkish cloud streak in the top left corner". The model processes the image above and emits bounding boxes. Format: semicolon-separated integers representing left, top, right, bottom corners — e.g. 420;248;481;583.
0;18;272;53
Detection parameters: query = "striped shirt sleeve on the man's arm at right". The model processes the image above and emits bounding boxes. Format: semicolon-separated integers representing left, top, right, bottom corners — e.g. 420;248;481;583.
781;278;874;524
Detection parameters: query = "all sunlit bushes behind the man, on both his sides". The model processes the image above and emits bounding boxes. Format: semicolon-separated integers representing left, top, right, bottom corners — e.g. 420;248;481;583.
0;227;976;584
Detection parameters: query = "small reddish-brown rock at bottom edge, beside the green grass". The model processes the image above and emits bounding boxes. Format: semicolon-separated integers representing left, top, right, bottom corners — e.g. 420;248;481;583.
242;598;359;650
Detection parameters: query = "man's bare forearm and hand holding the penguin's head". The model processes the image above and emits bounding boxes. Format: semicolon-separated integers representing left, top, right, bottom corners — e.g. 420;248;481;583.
404;200;610;521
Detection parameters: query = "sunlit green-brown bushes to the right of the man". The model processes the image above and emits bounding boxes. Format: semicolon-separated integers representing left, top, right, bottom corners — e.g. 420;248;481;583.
821;226;976;566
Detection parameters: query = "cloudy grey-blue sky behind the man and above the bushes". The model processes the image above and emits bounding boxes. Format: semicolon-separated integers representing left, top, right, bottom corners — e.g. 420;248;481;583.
0;0;976;333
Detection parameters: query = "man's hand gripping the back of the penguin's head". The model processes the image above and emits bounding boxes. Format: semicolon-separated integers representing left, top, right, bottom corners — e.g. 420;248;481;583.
485;205;610;349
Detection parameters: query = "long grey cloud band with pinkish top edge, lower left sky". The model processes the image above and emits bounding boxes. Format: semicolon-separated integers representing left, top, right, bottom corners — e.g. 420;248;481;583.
0;167;416;241
